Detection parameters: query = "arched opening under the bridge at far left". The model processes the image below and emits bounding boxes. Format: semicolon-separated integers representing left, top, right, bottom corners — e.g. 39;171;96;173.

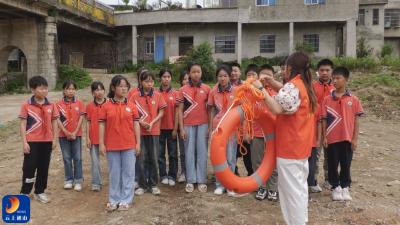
0;46;28;93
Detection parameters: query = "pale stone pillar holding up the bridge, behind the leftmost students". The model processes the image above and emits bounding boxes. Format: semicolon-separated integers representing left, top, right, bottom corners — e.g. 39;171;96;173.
38;17;58;89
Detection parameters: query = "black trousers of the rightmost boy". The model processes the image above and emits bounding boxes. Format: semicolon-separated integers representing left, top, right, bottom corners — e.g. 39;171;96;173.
327;141;353;189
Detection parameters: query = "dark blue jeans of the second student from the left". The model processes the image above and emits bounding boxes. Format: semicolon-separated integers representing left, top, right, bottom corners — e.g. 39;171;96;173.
59;137;83;184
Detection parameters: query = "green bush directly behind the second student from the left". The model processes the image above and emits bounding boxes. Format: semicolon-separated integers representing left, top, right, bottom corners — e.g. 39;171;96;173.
56;65;92;90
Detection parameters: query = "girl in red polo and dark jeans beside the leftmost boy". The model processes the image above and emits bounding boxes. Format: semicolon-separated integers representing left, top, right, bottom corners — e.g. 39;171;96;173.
57;80;85;191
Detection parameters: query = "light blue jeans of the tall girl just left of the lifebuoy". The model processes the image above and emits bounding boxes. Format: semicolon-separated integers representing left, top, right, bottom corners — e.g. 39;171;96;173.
185;124;208;184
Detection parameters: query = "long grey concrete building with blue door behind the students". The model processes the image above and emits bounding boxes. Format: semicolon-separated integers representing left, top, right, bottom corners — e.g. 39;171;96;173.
115;0;360;63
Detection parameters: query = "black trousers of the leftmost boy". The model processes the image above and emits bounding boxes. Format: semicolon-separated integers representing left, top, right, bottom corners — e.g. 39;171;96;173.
21;142;52;194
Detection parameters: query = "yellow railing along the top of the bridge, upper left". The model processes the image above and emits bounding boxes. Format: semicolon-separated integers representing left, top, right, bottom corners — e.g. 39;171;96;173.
58;0;114;25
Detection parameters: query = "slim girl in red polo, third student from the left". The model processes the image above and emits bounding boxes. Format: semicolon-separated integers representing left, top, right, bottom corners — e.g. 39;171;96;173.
86;81;107;191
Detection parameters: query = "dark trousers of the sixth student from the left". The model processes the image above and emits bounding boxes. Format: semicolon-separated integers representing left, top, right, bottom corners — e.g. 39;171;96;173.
158;130;178;180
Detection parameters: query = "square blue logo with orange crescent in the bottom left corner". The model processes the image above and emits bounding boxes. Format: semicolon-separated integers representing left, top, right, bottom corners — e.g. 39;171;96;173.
1;195;31;223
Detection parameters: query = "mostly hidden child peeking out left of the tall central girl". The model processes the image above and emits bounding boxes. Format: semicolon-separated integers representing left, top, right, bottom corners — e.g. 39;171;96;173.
176;70;189;183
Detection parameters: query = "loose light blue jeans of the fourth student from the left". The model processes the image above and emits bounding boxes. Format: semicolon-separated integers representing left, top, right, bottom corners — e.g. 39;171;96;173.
107;149;136;204
